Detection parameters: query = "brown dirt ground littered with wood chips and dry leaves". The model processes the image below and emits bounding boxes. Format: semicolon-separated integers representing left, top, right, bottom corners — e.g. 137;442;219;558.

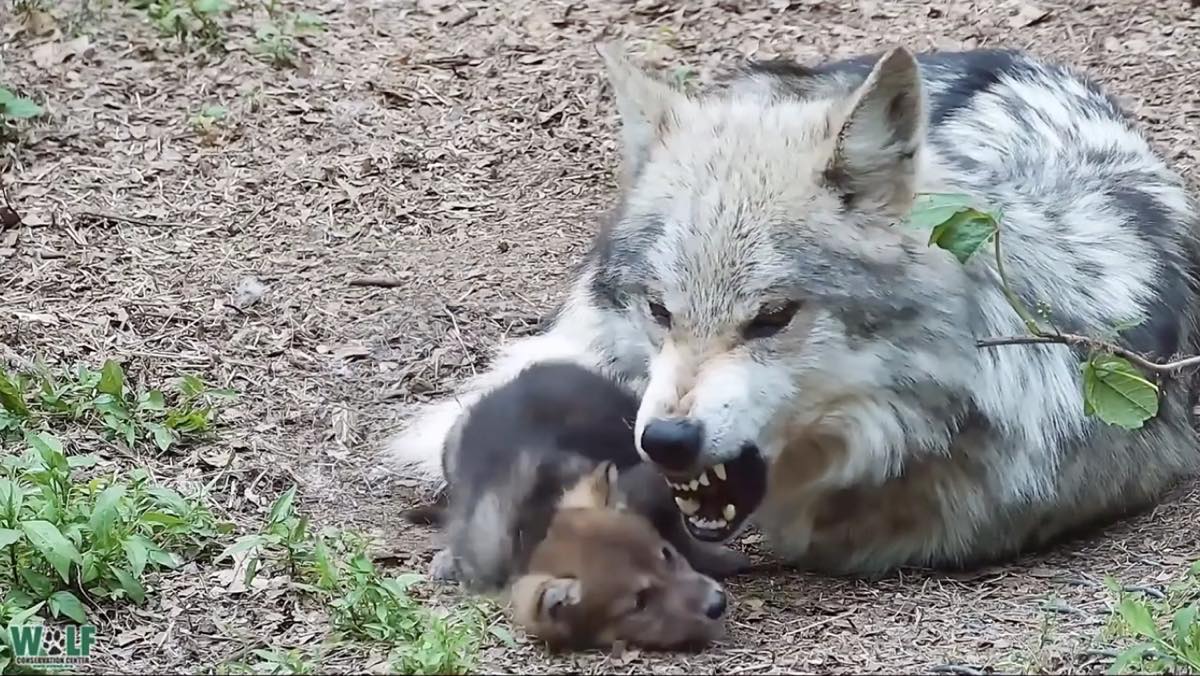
0;0;1200;674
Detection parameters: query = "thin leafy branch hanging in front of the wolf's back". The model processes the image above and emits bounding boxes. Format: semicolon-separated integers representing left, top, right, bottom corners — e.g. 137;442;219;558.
908;193;1200;430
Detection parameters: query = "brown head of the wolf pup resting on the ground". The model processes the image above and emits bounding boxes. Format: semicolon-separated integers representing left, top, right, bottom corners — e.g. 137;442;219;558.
510;461;726;650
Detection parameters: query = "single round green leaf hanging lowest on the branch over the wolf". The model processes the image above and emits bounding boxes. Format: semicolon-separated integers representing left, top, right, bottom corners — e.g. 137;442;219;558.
1081;354;1158;430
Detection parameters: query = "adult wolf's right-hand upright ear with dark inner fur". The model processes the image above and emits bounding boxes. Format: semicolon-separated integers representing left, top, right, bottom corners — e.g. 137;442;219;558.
826;47;925;210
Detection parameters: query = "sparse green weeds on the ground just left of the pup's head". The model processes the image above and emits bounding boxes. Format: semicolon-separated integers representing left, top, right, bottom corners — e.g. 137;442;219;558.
218;486;492;674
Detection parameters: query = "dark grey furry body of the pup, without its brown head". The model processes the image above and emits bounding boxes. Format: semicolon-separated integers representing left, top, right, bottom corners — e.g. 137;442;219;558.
404;363;749;590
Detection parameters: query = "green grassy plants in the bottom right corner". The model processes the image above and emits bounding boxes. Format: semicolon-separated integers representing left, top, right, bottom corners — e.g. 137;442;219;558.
1105;562;1200;674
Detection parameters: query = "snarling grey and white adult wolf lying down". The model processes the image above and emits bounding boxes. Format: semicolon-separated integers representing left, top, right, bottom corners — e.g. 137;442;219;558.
390;47;1200;574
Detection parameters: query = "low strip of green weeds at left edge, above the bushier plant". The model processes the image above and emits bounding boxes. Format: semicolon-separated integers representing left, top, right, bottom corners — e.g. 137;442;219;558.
0;360;235;450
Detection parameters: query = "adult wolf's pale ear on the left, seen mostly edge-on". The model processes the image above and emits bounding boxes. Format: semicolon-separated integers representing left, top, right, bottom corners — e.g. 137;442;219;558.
596;43;686;185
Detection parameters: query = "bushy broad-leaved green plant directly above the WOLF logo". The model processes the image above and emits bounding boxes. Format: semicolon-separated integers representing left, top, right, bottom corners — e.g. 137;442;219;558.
0;432;232;623
